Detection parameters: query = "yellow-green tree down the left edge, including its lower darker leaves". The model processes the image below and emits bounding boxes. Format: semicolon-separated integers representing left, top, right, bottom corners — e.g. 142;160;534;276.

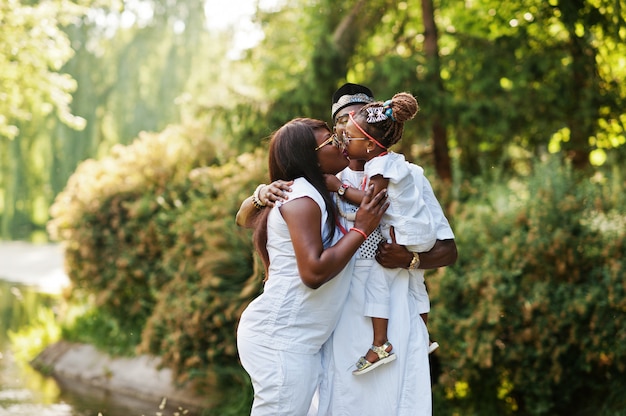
0;0;85;239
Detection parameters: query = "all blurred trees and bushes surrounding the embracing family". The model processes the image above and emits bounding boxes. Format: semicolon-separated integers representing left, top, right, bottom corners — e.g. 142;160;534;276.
0;0;626;415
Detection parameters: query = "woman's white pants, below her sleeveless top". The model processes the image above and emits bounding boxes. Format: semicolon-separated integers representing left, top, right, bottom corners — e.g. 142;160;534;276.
237;337;322;416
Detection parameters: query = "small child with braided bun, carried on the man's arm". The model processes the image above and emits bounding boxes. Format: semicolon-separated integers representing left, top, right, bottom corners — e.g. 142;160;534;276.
336;93;436;375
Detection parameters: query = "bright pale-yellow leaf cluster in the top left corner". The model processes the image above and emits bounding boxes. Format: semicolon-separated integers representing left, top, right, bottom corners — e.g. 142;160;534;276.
0;0;86;139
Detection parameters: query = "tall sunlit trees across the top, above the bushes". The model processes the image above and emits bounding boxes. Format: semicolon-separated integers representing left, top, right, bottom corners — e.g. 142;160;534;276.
0;0;626;238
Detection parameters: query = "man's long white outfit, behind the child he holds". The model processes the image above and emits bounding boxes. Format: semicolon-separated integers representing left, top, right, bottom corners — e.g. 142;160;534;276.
309;163;454;416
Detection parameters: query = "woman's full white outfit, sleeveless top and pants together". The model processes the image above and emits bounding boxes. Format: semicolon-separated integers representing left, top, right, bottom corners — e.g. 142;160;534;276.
237;178;353;416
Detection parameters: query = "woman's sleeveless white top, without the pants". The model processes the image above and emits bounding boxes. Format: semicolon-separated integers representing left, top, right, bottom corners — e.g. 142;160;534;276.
238;178;353;354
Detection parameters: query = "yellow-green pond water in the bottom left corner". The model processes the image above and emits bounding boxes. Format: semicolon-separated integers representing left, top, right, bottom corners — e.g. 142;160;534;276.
0;274;196;416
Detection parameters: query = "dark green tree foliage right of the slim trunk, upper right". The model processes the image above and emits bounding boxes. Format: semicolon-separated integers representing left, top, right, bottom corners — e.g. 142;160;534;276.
442;0;626;175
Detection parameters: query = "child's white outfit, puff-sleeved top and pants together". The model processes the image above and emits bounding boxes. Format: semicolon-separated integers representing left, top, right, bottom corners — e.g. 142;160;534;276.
364;152;437;318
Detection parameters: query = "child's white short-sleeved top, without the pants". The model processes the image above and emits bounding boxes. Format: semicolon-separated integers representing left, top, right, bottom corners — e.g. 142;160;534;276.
365;152;437;252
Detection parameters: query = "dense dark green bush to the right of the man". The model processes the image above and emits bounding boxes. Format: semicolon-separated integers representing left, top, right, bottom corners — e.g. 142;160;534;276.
429;160;626;415
